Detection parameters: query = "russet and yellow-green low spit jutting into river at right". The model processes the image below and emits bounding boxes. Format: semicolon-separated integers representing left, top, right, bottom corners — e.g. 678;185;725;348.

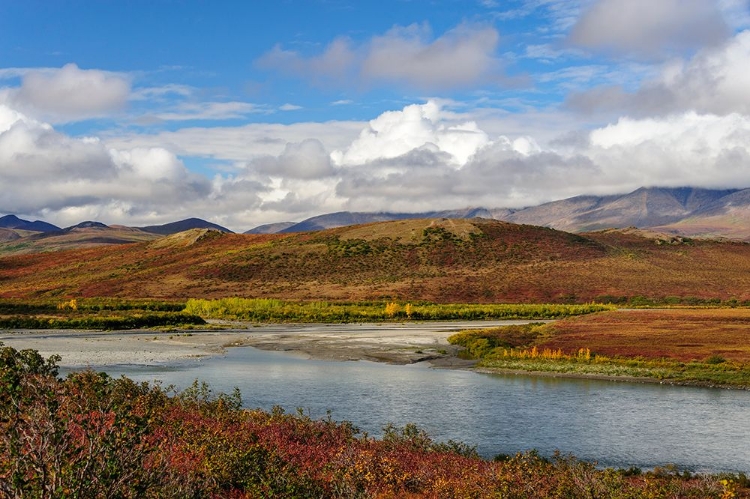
448;309;750;388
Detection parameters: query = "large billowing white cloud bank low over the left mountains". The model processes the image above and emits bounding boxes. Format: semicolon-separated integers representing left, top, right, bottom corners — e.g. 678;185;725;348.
0;105;211;221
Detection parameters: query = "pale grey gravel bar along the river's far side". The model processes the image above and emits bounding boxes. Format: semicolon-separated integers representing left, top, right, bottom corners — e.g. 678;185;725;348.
0;321;526;369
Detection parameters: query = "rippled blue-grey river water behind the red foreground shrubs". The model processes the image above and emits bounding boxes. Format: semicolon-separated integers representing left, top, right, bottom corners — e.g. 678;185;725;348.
85;347;750;472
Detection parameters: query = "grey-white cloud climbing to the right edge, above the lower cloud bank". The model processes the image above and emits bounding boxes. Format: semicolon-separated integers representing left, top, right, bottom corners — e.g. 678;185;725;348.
567;31;750;116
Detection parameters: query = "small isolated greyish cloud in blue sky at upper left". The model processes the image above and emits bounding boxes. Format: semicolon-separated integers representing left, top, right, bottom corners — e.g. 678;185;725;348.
4;64;130;122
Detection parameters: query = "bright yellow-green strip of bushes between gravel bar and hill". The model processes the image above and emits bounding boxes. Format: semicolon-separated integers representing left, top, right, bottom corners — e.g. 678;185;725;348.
185;298;614;322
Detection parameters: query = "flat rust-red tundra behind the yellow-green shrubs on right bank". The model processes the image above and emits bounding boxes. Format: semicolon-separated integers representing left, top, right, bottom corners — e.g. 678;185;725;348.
539;308;750;363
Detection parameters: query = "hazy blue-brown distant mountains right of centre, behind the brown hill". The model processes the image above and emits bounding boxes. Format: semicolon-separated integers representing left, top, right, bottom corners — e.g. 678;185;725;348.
253;187;750;241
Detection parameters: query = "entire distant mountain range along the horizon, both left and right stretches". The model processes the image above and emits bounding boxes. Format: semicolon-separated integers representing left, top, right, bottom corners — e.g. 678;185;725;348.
0;187;750;254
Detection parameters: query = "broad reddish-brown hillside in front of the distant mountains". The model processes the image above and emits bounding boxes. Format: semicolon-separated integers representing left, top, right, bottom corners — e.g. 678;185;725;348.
0;219;750;302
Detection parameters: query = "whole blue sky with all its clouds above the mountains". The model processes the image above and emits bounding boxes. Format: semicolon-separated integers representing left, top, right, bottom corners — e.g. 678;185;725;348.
0;0;750;232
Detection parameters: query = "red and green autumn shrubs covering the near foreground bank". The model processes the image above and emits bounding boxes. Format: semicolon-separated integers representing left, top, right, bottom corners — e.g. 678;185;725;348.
0;346;748;499
